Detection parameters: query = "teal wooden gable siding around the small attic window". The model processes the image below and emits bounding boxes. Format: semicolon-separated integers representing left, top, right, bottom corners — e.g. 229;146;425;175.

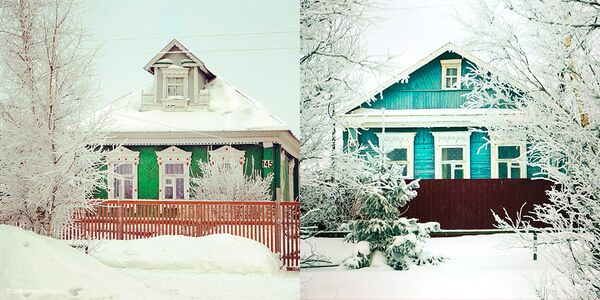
362;52;472;109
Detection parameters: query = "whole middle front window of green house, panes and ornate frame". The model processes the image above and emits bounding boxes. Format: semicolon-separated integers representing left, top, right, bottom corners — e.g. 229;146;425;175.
157;146;192;199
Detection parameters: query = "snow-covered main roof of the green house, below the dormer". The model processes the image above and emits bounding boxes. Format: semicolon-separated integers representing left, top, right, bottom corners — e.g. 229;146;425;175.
101;78;300;157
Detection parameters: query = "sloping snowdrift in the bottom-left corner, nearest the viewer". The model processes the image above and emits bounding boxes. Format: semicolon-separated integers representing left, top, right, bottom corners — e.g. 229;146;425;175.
0;225;160;299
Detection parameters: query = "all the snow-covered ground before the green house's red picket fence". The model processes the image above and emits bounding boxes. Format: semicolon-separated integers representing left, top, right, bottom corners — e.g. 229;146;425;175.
0;225;300;300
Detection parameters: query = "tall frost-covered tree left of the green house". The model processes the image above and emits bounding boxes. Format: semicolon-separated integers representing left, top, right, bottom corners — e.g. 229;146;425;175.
0;0;106;235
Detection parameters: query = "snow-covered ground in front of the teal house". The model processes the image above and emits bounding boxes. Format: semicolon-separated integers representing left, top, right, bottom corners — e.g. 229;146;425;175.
301;234;554;299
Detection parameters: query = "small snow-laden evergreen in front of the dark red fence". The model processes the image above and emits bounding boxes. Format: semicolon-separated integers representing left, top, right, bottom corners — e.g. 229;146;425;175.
344;153;442;270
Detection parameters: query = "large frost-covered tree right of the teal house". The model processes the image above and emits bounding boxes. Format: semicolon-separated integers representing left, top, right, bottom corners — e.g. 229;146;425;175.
469;0;600;299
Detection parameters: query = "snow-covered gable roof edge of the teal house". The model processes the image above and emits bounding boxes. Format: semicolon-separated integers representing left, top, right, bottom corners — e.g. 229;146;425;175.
338;42;522;115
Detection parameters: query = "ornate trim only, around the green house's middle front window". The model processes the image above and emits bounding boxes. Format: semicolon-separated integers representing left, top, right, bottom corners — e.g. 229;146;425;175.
156;146;192;200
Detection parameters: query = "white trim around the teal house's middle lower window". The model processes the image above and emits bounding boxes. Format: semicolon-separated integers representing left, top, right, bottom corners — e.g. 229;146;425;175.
431;131;471;179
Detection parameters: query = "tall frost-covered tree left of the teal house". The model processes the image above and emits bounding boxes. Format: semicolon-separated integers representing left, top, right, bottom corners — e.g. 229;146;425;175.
300;0;394;228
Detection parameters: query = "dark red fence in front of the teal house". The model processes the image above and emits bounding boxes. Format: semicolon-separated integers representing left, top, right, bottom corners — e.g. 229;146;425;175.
401;179;551;229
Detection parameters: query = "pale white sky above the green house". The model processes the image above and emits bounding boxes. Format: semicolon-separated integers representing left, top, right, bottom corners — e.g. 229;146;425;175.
82;0;300;134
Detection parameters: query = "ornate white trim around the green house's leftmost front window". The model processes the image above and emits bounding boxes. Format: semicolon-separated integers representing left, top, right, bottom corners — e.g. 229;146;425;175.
106;146;140;199
